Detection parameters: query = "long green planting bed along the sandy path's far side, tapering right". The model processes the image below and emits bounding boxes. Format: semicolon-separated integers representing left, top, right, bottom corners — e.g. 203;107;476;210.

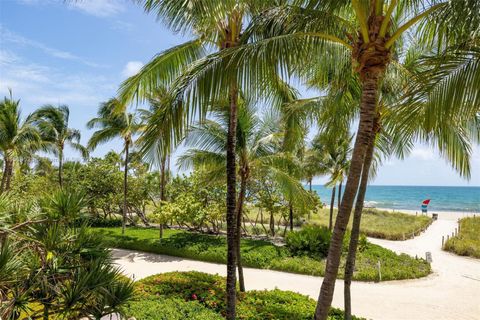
92;228;431;281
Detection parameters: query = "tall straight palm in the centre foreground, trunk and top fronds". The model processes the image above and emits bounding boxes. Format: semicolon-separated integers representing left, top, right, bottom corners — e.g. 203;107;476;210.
120;0;288;319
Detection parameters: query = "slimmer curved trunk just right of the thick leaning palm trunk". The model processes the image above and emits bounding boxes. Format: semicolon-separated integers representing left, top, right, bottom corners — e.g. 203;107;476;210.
343;129;375;320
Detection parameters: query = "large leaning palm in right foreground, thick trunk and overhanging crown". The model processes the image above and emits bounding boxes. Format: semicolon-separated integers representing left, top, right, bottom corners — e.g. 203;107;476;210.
216;0;477;320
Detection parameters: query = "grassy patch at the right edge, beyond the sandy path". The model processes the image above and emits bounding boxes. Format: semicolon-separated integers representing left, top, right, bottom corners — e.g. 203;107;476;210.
444;217;480;258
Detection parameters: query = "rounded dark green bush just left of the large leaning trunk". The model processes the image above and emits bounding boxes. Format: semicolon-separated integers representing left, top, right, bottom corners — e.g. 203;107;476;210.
285;225;331;258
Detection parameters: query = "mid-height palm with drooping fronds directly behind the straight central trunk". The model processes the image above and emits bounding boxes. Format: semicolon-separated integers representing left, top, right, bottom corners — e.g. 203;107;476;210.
178;100;311;291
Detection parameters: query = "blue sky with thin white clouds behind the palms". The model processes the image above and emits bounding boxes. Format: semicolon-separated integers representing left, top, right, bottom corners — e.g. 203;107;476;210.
0;0;480;186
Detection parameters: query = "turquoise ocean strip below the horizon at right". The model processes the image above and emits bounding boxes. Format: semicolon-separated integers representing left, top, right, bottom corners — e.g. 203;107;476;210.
306;185;480;212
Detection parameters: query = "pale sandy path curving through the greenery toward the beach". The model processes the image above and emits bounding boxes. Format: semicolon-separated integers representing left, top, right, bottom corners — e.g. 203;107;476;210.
114;216;480;320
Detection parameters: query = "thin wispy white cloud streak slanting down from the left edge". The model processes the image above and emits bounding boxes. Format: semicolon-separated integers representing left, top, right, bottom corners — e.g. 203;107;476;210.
0;25;101;67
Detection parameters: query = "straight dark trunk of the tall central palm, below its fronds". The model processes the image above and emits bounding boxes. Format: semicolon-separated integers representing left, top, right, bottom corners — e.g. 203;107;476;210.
226;85;238;320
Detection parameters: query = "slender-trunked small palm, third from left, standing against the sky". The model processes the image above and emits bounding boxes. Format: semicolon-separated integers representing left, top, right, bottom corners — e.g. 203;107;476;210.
87;98;142;234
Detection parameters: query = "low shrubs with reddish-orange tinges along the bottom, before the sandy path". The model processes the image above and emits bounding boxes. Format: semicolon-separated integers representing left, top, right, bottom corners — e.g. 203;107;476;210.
127;271;366;320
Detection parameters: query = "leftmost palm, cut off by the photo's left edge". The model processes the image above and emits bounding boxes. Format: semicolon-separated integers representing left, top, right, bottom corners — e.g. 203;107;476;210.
0;92;42;192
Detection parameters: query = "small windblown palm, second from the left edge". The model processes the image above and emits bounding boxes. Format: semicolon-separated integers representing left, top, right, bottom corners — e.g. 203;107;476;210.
33;105;88;187
